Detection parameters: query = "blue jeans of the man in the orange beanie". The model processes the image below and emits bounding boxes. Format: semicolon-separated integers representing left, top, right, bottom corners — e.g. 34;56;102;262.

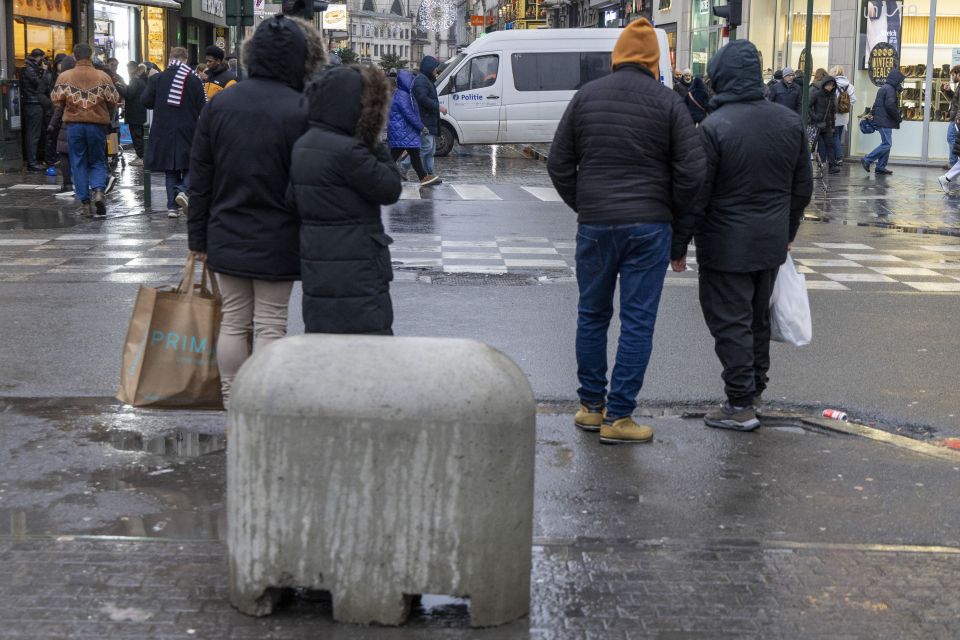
576;223;673;420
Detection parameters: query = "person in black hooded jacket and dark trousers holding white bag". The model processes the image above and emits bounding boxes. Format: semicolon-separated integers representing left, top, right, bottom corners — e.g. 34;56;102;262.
671;40;813;431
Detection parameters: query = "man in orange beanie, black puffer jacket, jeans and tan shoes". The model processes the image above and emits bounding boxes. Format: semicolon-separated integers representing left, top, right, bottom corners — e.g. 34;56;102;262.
547;18;704;444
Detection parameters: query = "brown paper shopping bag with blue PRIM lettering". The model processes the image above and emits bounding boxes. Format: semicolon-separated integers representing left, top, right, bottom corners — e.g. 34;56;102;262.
117;254;223;408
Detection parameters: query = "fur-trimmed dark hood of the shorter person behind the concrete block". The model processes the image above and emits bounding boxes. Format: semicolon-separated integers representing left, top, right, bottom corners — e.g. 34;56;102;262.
307;65;389;148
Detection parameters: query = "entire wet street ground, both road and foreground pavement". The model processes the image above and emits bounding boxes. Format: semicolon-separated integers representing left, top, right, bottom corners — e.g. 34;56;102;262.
0;151;960;640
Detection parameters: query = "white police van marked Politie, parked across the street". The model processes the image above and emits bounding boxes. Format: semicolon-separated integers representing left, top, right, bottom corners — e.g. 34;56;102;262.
436;29;673;156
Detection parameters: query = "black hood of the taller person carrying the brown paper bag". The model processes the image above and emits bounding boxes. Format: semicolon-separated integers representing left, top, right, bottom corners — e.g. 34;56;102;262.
244;15;307;91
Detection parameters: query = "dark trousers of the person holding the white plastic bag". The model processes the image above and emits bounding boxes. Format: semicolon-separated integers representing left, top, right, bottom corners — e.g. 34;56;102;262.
700;268;780;407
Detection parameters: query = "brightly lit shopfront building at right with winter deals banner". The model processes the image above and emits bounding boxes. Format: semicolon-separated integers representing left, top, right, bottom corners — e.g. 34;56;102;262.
653;0;960;164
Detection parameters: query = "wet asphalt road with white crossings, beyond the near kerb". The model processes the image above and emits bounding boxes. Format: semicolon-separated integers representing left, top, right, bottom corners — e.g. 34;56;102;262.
0;152;960;436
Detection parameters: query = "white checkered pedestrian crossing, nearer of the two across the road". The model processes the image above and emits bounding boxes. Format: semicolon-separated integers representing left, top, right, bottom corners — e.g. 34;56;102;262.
0;229;960;295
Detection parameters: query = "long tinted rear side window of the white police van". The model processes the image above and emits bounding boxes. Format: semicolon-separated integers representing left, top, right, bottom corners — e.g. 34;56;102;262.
510;51;610;91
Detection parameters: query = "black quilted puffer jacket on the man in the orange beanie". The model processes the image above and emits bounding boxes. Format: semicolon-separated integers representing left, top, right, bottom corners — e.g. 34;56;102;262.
547;64;704;224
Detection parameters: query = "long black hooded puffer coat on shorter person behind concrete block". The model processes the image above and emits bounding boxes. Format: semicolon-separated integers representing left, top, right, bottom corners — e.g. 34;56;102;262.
289;66;402;335
